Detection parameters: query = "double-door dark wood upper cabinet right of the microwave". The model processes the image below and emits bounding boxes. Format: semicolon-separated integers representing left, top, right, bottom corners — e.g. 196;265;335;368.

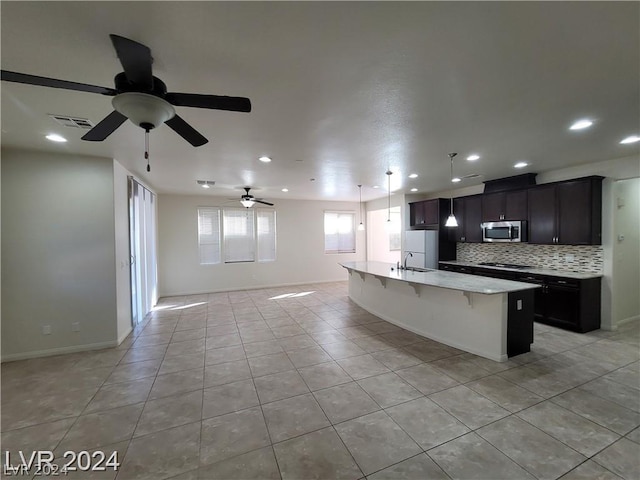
528;177;603;245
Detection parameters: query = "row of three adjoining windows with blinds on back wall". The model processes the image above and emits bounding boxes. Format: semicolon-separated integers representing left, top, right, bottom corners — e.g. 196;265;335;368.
198;207;276;265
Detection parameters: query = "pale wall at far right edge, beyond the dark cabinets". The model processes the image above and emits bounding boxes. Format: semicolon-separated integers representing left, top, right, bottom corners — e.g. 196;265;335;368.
612;178;640;326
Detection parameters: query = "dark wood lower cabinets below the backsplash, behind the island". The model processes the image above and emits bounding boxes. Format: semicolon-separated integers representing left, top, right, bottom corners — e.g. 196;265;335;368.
440;263;601;333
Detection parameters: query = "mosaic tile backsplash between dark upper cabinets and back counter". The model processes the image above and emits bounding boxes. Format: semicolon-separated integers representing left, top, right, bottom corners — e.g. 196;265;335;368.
456;243;603;273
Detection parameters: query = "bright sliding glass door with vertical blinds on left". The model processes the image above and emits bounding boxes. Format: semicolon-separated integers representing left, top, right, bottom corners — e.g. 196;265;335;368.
129;177;158;326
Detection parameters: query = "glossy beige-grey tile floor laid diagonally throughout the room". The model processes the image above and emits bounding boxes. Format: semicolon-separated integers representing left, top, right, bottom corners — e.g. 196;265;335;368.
2;283;640;480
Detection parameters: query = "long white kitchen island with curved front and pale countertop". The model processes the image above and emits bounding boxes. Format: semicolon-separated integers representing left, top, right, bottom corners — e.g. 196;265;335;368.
341;262;539;362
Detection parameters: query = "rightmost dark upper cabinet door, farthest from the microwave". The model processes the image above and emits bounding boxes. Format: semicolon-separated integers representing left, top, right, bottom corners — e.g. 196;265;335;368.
556;180;592;245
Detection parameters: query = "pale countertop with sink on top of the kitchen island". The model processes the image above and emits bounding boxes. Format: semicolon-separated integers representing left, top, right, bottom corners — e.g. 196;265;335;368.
340;262;540;295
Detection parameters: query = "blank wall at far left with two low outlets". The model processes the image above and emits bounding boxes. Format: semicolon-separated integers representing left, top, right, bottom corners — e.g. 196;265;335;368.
1;150;116;360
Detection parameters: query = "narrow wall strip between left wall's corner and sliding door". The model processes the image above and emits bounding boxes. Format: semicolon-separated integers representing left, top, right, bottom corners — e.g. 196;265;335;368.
113;160;132;343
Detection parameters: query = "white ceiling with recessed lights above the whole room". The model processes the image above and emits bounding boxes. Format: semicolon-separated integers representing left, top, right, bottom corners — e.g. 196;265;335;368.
1;1;640;201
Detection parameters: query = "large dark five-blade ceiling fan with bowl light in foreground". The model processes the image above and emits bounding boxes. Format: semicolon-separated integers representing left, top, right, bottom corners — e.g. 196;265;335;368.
1;35;251;147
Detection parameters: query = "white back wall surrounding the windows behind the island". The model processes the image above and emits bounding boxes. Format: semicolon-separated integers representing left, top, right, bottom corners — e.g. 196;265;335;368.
158;194;365;297
